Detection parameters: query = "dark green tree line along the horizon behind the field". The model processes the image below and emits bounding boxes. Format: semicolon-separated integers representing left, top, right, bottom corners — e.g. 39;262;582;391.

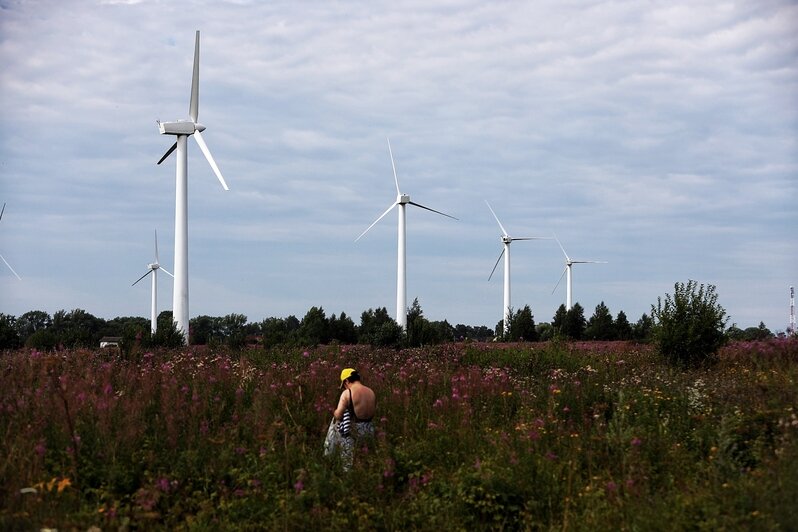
0;290;773;350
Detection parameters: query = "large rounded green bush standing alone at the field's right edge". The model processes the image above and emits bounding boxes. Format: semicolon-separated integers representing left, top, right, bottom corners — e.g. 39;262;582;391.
651;280;728;365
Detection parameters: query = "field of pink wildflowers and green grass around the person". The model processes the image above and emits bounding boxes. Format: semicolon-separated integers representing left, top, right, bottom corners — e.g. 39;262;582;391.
0;338;798;530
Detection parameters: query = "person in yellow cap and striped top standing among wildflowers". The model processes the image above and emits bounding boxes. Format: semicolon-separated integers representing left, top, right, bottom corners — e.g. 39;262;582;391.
324;368;377;471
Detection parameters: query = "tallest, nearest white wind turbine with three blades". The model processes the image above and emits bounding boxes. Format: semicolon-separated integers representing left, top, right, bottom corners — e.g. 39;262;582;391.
158;30;229;344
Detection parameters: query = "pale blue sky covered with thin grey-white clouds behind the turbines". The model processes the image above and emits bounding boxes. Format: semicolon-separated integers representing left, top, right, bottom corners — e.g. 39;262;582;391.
0;0;798;331
